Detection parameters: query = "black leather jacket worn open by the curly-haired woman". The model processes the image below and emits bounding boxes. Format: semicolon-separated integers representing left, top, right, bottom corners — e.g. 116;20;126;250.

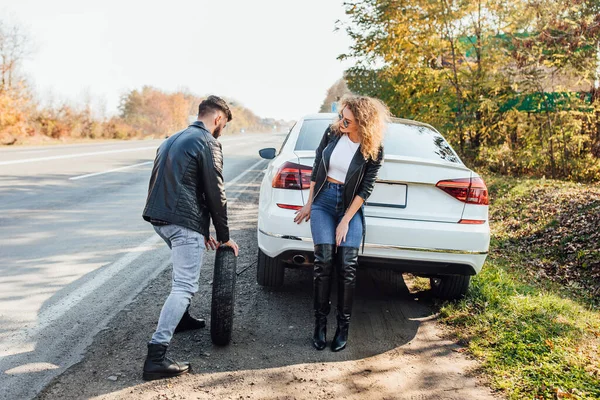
311;127;383;247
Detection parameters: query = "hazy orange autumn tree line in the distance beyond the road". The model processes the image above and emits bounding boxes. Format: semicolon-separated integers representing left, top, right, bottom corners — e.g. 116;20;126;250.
0;20;272;144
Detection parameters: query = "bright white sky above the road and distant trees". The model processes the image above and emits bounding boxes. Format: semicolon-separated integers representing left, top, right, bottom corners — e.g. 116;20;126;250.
0;0;351;120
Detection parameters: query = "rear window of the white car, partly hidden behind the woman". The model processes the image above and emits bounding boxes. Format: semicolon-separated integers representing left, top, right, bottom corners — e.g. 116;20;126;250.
295;119;461;164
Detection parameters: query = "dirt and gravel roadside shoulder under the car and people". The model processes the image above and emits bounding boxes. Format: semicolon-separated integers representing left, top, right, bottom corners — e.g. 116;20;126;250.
38;175;498;400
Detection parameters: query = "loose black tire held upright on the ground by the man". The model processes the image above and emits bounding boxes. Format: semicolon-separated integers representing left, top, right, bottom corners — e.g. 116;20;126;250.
210;246;237;346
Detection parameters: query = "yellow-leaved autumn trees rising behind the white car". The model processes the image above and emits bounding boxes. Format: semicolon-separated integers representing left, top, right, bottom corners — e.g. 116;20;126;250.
340;0;600;179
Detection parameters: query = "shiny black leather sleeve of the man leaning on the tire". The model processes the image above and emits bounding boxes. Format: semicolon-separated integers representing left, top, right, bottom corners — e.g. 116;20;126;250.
200;140;229;243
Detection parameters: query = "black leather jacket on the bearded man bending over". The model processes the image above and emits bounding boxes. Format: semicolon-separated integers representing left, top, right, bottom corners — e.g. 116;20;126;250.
143;121;229;243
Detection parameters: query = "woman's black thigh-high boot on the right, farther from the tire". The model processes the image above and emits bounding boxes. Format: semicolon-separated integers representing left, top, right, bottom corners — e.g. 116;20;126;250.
331;247;358;351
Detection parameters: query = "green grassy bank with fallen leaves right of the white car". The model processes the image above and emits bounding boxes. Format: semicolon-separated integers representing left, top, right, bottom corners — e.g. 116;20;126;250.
440;176;600;399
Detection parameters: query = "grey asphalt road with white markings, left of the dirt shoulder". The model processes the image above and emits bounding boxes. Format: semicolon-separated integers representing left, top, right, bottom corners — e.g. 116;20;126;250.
0;134;284;399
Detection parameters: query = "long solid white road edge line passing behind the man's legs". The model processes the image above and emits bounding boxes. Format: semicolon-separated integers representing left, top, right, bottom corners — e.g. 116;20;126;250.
0;160;265;359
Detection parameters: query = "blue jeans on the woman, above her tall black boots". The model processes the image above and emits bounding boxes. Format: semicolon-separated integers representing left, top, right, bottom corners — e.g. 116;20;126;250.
310;181;363;248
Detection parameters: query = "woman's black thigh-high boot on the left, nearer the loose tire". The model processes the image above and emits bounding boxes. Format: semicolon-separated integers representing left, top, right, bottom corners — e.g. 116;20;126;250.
313;244;335;350
